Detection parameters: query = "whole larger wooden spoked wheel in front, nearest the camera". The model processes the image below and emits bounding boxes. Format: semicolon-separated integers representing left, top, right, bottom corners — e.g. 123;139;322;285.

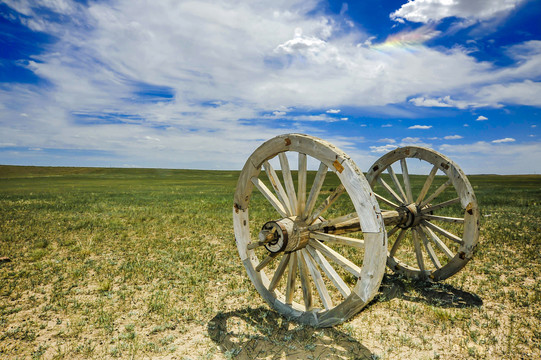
233;134;387;327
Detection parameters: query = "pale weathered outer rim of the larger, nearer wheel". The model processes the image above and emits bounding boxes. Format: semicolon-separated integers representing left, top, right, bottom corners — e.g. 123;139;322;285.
233;134;387;327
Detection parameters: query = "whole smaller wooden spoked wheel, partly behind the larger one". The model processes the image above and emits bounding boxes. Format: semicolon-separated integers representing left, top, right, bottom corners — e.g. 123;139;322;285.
366;146;479;281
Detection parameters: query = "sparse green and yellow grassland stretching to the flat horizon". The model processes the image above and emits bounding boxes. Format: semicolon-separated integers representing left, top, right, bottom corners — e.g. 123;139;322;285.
0;166;541;359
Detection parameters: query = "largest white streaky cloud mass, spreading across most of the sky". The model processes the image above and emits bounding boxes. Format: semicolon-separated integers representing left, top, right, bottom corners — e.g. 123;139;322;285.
0;0;541;172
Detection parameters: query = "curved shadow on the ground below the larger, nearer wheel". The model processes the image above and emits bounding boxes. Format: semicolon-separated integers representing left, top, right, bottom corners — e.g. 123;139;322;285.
207;307;374;359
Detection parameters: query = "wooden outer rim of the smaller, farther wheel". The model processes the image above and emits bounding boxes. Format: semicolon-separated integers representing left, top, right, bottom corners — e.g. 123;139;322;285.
366;146;480;281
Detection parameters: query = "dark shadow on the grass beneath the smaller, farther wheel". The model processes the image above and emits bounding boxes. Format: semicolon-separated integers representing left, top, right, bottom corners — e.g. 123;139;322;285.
376;274;483;308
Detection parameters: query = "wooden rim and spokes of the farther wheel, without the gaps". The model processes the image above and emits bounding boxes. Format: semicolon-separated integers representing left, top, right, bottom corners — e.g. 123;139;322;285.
366;146;479;281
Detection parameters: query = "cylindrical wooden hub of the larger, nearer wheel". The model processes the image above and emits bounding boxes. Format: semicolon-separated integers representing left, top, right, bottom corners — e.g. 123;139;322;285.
259;216;309;253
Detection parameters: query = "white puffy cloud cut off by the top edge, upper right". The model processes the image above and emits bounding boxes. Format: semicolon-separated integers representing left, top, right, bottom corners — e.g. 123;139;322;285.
390;0;524;23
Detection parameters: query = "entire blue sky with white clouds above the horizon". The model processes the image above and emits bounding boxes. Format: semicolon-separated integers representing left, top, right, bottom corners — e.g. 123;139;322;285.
0;0;541;174
